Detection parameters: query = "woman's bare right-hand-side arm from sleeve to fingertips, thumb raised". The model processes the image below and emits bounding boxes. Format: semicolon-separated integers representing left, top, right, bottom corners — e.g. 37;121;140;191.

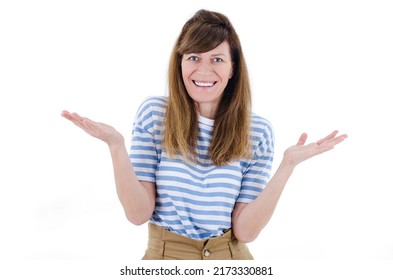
232;131;347;242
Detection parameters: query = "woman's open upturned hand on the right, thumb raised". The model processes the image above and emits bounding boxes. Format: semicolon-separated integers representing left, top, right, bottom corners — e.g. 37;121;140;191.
283;130;348;168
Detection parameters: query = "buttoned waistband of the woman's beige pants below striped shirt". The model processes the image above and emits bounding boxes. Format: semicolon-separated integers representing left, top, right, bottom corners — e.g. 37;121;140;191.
149;222;235;250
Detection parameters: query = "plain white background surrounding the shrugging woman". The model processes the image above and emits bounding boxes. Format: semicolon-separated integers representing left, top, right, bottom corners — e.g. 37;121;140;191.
0;0;393;274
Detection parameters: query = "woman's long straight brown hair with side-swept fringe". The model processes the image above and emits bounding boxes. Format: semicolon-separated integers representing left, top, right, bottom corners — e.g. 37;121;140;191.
164;10;251;166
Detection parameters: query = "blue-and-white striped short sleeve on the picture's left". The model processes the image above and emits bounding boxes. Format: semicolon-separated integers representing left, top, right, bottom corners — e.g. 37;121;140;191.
130;99;159;182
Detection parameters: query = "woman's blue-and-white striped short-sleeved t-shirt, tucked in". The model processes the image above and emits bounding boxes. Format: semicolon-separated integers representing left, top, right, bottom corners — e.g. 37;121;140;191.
130;97;274;240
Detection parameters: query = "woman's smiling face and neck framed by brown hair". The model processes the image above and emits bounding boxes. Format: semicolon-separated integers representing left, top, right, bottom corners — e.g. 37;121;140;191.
181;41;232;119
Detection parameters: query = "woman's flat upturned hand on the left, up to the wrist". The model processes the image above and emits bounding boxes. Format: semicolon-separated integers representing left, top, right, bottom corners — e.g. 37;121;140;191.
61;111;124;147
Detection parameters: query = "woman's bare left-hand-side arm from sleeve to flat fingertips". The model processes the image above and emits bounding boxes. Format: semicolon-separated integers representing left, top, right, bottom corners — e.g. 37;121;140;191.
62;111;156;225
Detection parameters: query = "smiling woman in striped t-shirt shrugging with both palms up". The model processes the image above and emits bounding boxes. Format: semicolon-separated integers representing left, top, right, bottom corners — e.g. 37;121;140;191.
62;10;346;259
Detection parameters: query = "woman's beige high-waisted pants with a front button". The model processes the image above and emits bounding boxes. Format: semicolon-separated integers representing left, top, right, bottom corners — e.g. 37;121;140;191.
143;223;254;260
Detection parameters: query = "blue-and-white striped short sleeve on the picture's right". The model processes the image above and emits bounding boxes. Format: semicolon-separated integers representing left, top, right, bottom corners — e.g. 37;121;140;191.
236;119;274;203
